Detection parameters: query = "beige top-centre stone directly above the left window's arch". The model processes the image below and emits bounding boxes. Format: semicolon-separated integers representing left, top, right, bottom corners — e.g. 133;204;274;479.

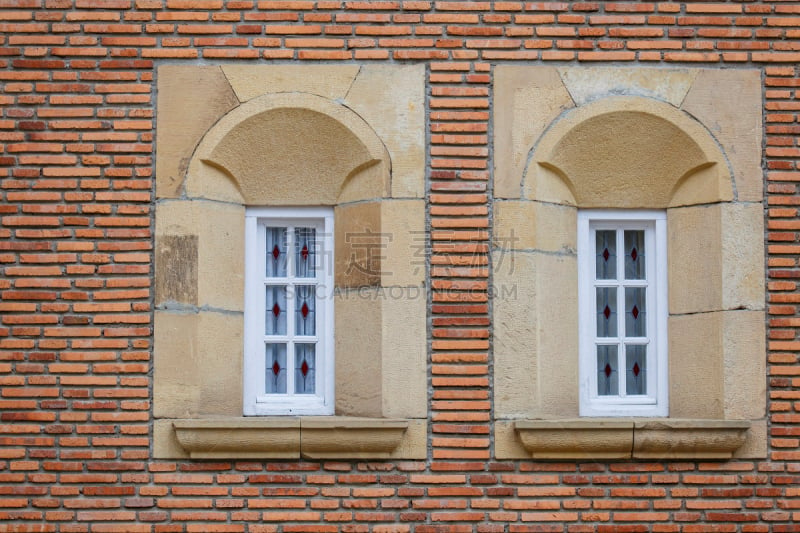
221;65;360;102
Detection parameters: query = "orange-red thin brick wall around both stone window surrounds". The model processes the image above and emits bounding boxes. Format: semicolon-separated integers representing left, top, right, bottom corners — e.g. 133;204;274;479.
0;0;800;533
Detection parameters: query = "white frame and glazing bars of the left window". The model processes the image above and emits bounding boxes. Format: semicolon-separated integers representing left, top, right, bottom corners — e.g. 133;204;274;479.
242;207;335;416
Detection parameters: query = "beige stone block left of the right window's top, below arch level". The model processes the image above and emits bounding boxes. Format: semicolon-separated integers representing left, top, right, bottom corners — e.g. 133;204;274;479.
492;200;578;254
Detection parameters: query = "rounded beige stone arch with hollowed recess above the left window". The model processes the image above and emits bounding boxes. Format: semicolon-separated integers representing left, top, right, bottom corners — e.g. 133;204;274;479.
184;93;391;205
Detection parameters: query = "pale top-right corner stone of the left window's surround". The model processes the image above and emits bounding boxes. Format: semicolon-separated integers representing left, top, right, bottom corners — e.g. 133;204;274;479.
345;64;425;198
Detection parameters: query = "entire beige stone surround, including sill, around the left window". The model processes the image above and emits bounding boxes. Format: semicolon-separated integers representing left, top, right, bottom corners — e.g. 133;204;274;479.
154;65;427;459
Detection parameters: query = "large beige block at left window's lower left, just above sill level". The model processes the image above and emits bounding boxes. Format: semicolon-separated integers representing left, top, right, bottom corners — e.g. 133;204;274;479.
153;311;243;418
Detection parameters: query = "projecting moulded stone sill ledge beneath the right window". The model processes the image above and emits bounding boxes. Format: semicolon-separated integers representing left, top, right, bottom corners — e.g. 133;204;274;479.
514;418;750;460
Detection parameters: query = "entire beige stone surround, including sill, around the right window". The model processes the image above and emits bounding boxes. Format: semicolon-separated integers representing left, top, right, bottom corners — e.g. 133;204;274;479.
493;66;767;459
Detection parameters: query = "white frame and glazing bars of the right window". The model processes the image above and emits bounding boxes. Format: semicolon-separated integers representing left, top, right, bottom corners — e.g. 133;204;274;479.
578;209;669;417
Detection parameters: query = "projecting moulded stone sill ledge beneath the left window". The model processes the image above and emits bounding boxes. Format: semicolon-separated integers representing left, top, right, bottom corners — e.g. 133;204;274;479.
172;416;411;459
